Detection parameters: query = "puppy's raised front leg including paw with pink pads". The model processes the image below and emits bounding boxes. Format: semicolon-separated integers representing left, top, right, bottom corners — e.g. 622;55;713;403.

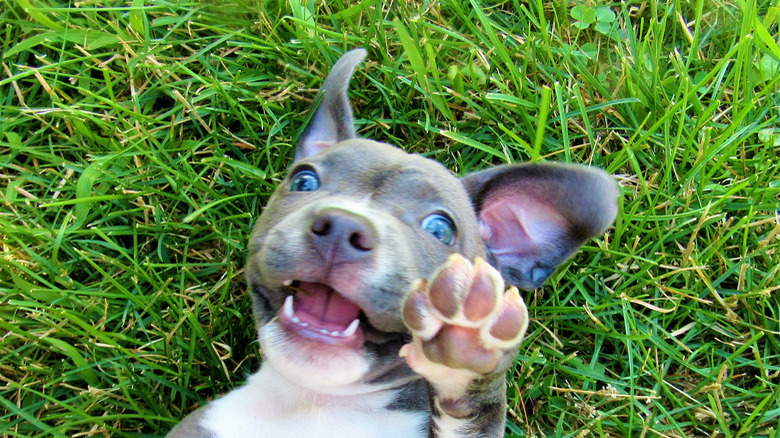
401;254;528;438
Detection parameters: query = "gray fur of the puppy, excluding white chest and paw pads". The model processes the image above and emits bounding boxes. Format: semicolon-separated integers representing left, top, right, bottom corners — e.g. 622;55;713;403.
168;49;617;438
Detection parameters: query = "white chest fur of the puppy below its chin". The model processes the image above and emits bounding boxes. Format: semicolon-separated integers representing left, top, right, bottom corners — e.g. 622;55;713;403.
202;367;428;438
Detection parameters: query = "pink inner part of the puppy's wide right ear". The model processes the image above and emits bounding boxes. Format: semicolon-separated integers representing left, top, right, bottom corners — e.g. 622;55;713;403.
479;192;569;256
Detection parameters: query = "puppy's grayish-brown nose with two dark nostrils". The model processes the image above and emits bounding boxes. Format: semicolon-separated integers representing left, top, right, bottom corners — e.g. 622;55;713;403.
311;208;377;263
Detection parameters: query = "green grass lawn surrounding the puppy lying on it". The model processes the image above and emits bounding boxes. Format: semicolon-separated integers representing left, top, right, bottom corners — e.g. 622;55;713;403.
0;0;780;438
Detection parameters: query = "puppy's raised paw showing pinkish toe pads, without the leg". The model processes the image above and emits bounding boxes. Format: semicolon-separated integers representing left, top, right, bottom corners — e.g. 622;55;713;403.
401;254;528;377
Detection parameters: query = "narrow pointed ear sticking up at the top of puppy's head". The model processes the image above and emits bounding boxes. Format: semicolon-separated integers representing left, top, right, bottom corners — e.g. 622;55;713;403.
295;49;366;161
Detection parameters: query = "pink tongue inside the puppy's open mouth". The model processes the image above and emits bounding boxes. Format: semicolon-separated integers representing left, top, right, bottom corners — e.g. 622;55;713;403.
295;281;360;330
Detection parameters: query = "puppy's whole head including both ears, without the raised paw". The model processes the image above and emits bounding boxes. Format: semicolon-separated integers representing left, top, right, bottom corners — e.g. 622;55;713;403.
247;49;617;393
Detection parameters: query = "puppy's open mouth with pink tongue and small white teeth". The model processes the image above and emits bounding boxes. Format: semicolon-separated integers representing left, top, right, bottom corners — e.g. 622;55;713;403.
278;281;365;349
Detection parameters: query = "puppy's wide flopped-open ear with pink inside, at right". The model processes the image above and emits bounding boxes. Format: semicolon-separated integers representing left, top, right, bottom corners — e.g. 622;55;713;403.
462;164;618;290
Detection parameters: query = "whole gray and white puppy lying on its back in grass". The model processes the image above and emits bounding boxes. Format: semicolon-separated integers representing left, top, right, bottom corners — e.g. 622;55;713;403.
168;49;617;438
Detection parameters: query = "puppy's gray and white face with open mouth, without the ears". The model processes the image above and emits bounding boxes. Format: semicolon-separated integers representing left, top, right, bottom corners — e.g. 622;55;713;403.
247;139;484;391
